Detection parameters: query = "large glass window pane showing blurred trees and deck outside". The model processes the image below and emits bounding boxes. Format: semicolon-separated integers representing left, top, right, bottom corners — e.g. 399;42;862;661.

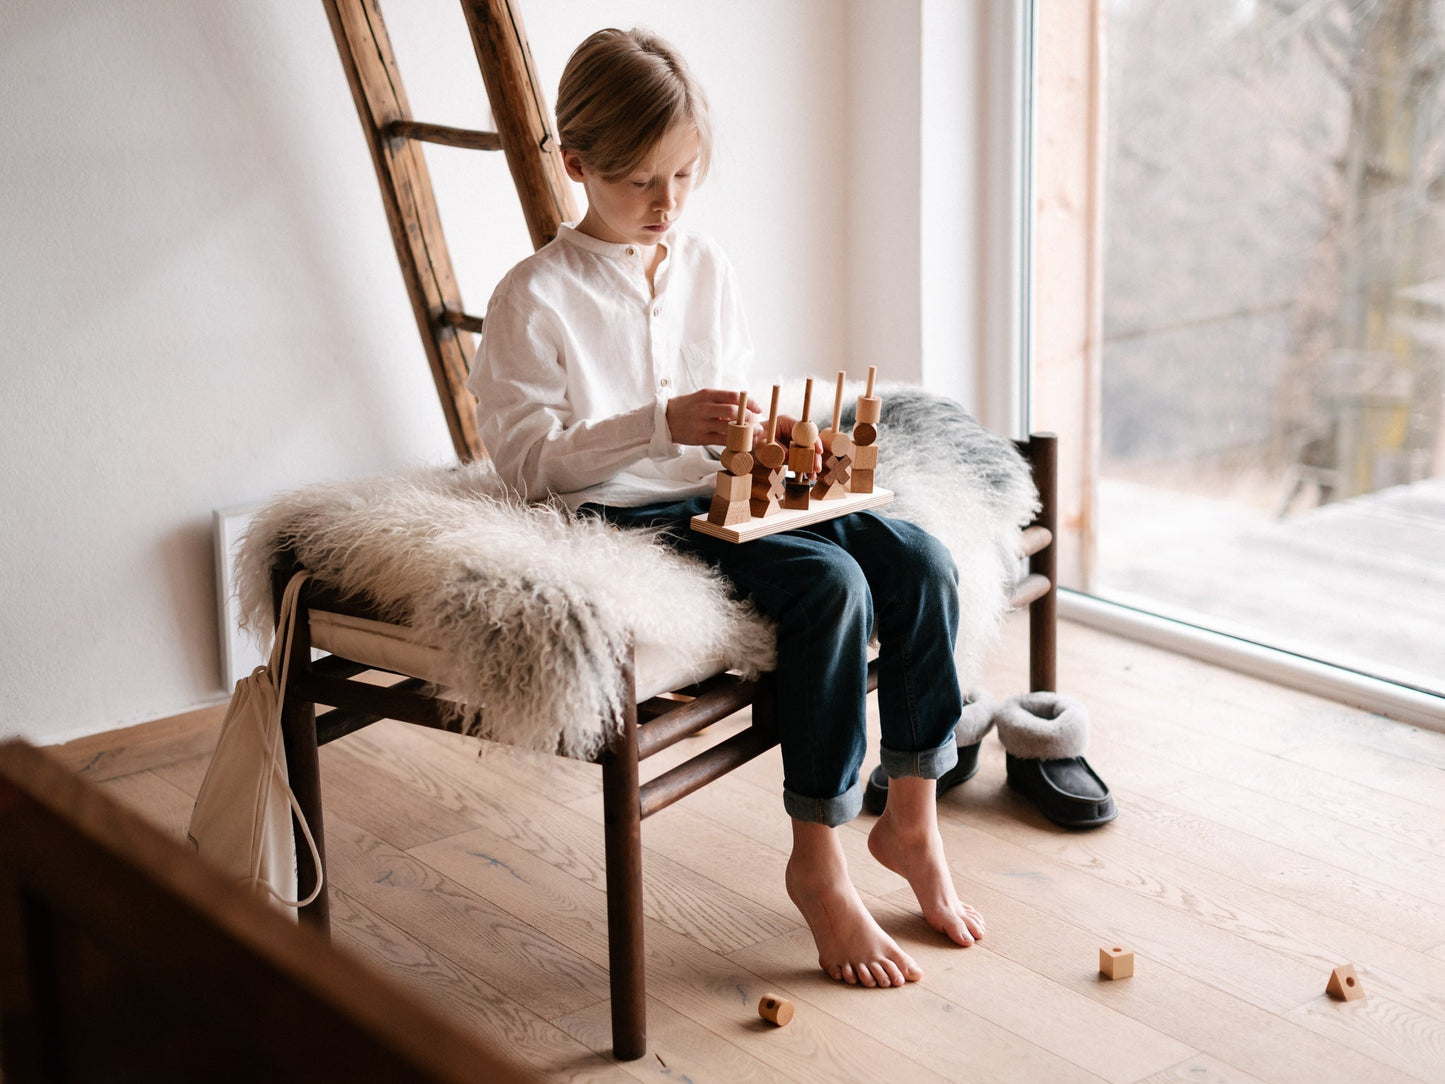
1038;0;1445;705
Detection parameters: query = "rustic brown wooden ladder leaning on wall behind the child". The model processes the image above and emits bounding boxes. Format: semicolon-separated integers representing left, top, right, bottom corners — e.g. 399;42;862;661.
322;0;577;463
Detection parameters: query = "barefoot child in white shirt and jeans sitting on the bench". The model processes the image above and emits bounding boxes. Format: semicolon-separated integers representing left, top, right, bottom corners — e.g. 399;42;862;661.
468;30;984;986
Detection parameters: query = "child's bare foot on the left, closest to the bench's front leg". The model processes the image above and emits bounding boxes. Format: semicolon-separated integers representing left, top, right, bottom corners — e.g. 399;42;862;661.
788;821;923;986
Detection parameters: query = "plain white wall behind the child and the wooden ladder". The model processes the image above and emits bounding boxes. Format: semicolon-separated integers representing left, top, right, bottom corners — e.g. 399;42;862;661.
0;0;1005;741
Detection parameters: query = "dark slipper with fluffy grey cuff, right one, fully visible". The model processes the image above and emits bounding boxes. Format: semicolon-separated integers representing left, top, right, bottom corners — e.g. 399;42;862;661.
994;692;1118;828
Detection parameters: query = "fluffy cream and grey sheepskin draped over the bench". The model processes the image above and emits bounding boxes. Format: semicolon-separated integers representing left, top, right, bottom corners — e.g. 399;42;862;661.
237;386;1036;759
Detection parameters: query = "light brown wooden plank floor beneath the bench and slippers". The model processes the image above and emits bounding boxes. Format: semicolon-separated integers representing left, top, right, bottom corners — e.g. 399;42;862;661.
59;619;1445;1084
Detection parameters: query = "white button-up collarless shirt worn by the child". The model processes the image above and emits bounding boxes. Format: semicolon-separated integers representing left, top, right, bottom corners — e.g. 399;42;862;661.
467;225;753;509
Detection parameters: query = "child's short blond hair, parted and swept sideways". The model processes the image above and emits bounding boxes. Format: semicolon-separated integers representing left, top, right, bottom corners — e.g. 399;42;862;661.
556;29;712;182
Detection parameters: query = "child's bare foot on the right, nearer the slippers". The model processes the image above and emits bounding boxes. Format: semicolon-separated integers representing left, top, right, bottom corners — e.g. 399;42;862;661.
868;779;984;945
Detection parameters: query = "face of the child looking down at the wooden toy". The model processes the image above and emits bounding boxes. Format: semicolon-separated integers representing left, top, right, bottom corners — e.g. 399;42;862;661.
562;126;698;246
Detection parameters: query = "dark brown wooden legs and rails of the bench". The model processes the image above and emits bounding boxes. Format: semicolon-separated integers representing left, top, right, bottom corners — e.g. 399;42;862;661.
273;434;1058;1061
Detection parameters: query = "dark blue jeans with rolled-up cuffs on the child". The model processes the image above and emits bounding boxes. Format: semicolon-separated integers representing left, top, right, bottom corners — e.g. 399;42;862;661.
582;497;962;825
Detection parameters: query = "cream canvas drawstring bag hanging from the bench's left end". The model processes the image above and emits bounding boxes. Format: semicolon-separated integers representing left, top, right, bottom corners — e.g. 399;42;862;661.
186;572;322;908
